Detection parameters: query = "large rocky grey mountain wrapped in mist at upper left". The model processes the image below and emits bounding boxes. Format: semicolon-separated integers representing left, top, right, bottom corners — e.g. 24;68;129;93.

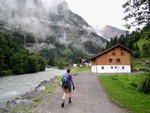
0;0;106;54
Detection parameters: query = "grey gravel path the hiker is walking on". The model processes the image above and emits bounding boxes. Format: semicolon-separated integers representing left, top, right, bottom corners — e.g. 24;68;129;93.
35;71;127;113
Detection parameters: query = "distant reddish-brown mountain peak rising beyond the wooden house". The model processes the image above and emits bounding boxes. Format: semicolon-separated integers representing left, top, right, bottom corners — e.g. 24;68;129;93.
96;25;127;40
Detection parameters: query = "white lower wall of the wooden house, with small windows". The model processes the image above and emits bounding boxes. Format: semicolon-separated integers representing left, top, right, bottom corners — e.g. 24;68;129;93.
92;65;131;73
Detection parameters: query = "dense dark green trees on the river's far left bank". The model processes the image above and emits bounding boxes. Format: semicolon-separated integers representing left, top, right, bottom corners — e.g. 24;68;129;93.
0;34;45;76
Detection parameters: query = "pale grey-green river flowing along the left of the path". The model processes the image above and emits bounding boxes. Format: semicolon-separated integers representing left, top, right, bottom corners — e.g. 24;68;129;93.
0;68;65;107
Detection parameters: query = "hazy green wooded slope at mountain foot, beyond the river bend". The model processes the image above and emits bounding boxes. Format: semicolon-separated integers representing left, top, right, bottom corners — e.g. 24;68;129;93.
40;45;88;69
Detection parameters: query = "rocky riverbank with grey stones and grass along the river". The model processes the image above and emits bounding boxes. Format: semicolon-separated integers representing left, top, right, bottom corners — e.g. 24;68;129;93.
0;77;58;113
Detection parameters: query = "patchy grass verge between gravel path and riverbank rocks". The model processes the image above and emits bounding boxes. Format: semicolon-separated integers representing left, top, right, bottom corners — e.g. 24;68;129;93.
6;76;62;113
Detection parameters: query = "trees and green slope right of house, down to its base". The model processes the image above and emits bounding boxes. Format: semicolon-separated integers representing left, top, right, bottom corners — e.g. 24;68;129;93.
106;23;150;71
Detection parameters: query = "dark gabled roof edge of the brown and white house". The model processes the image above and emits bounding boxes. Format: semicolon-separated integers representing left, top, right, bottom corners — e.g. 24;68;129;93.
91;44;131;60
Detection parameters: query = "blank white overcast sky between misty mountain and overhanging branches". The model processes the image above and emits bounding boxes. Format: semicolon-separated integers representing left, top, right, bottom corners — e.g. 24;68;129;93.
65;0;127;29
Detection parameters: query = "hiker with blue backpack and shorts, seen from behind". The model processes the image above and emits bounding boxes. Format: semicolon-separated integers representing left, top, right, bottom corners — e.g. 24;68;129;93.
61;69;75;107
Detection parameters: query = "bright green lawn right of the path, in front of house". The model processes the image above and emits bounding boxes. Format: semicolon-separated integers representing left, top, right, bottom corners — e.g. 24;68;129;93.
98;75;150;113
